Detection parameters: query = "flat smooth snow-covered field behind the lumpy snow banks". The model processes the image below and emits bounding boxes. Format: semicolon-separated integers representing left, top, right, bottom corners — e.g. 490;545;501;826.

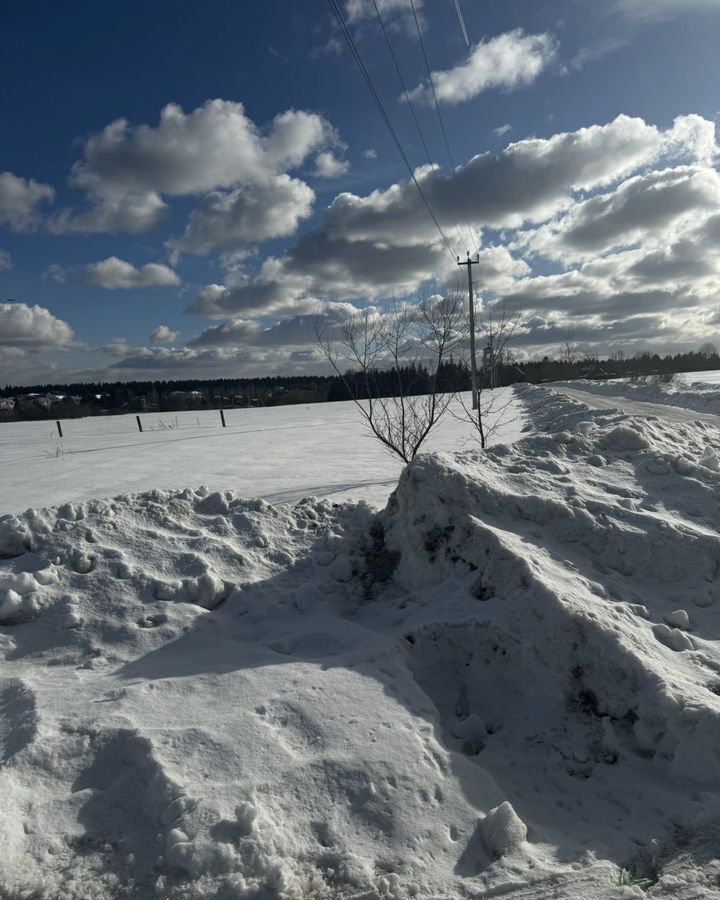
0;388;522;514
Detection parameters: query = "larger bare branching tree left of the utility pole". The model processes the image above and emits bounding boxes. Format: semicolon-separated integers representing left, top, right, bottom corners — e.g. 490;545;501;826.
316;294;464;463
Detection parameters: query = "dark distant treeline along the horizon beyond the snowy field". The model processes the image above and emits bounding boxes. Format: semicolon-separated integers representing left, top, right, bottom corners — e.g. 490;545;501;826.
0;345;720;421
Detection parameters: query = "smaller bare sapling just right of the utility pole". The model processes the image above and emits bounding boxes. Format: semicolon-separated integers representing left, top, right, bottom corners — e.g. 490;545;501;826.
454;303;520;450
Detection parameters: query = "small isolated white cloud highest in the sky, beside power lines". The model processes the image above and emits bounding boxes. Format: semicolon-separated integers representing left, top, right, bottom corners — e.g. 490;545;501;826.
401;28;557;104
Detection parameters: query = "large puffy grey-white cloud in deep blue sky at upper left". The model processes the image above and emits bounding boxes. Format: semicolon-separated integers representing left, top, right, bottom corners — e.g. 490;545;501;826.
48;100;339;243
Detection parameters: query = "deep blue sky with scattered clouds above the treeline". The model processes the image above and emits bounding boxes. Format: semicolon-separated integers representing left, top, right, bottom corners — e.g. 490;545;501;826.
0;0;720;383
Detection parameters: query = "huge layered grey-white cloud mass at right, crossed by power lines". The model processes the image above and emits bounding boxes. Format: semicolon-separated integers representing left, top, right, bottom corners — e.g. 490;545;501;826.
191;116;720;362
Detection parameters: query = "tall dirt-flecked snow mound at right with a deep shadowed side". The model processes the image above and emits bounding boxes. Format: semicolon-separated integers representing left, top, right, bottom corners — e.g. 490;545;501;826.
383;388;720;897
